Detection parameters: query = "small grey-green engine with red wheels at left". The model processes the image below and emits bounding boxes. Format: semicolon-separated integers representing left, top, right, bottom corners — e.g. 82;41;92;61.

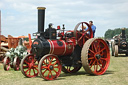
3;39;28;71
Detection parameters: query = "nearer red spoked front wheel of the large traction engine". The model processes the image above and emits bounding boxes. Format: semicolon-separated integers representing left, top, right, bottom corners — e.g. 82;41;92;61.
38;55;61;80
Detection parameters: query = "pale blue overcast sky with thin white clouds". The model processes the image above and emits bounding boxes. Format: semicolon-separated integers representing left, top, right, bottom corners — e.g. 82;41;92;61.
0;0;128;37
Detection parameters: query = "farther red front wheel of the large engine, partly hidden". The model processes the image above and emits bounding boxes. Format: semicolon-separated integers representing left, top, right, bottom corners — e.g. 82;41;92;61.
21;54;38;78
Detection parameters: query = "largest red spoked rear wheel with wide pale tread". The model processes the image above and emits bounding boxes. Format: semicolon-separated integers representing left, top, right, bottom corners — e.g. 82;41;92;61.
81;38;110;75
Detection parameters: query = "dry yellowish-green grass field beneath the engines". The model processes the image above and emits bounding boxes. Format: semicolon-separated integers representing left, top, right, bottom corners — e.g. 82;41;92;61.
0;56;128;85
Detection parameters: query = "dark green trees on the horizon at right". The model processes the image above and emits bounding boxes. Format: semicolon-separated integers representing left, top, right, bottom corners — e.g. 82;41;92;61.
104;28;128;39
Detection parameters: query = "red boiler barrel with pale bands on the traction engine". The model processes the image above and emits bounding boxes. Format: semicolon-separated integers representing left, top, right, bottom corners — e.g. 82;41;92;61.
48;39;75;56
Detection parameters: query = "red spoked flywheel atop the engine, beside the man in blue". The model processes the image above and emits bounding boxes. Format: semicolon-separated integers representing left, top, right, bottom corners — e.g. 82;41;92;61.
74;22;93;47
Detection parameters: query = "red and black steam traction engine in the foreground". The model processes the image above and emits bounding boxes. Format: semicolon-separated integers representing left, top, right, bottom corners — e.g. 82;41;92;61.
21;7;110;80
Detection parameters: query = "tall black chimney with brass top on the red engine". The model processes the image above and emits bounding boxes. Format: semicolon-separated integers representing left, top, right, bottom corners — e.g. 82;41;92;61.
37;7;46;36
